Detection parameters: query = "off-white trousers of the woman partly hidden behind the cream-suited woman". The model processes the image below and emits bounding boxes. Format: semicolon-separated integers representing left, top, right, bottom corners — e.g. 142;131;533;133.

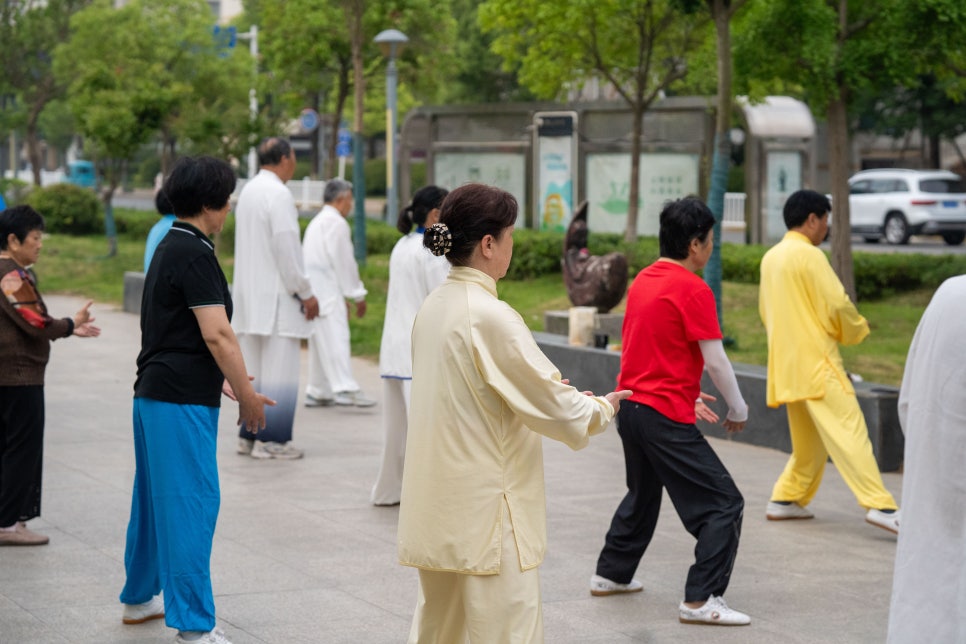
369;378;413;505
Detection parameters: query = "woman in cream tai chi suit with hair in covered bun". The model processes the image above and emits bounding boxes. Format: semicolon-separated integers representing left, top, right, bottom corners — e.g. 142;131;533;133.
398;184;630;644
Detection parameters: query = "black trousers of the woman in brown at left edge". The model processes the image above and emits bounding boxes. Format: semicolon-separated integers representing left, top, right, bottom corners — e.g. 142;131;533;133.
0;385;44;528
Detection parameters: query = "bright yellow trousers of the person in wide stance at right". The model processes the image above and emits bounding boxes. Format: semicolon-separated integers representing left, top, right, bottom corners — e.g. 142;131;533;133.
771;365;898;510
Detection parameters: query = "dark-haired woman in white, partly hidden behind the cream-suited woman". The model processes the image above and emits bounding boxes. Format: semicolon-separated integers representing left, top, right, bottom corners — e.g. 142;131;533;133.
370;186;449;506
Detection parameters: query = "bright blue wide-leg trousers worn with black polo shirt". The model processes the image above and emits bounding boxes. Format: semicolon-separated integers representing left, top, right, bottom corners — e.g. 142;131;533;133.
120;398;221;631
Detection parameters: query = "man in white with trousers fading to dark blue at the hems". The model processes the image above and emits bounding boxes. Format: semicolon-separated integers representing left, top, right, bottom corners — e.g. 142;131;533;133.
231;137;319;460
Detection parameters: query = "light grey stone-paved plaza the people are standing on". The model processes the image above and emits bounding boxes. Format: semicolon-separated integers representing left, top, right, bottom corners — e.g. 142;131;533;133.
0;296;901;644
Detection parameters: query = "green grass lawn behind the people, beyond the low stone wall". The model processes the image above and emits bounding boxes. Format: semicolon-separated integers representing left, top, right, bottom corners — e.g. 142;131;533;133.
35;234;932;386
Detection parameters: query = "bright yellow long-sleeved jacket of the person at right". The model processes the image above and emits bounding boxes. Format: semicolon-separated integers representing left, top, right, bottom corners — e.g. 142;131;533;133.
758;231;869;407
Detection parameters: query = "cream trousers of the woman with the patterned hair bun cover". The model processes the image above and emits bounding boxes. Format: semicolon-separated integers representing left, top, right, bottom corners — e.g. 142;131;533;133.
409;503;543;644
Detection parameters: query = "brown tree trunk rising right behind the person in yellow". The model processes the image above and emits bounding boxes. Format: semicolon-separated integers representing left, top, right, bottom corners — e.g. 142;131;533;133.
827;96;856;301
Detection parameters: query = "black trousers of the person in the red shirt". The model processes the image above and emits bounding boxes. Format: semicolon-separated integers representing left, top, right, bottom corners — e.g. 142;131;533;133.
597;400;745;602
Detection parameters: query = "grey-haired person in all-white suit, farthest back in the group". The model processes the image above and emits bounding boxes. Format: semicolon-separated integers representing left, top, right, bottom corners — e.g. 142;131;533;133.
302;179;376;407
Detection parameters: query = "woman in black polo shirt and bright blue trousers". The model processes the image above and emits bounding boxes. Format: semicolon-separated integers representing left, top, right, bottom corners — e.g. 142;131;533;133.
120;157;275;644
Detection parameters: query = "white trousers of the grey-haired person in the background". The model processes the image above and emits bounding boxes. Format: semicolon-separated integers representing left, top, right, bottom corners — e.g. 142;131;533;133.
305;306;359;398
